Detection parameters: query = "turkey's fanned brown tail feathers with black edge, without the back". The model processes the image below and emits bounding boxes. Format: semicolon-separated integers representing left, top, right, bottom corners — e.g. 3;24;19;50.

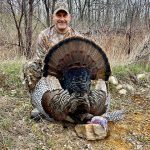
43;37;111;81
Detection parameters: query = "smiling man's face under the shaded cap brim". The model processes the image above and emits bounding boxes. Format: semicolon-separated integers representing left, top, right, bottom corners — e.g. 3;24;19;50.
53;10;71;32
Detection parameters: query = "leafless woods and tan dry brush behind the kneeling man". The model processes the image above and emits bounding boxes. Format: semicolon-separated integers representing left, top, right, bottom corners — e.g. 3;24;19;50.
0;0;150;65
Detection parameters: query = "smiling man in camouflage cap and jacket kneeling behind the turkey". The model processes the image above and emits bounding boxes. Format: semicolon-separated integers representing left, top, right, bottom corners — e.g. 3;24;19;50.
24;2;79;92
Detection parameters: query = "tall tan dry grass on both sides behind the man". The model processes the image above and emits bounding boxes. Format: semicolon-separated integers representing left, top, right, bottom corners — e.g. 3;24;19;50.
0;16;150;67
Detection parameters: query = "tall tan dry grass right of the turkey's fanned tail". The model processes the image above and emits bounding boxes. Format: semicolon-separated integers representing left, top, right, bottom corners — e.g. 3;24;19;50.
94;28;150;67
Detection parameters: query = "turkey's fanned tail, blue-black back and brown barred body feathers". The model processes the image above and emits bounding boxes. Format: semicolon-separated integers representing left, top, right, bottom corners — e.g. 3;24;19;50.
42;37;111;120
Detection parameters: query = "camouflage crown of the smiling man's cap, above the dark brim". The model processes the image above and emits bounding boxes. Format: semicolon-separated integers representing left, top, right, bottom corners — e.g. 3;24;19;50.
54;0;69;14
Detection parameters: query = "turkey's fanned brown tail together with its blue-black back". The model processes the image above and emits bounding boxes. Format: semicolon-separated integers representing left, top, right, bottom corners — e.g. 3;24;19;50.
44;37;111;93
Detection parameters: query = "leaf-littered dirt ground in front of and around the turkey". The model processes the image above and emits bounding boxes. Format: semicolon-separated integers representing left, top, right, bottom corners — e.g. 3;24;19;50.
0;76;150;150
